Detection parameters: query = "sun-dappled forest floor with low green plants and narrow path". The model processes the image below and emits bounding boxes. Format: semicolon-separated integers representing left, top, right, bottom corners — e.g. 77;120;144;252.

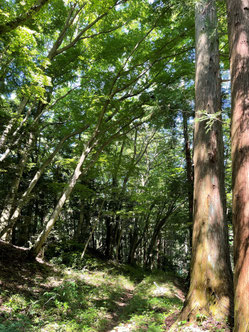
0;241;229;332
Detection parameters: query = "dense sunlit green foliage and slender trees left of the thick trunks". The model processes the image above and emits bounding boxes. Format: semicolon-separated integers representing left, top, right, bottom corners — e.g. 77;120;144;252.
0;0;194;273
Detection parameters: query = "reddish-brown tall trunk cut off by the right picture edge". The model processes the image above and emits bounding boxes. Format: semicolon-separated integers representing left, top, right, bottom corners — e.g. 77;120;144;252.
227;0;249;332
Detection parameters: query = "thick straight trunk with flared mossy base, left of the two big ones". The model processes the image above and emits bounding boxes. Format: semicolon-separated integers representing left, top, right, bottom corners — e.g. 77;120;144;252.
180;0;232;321
